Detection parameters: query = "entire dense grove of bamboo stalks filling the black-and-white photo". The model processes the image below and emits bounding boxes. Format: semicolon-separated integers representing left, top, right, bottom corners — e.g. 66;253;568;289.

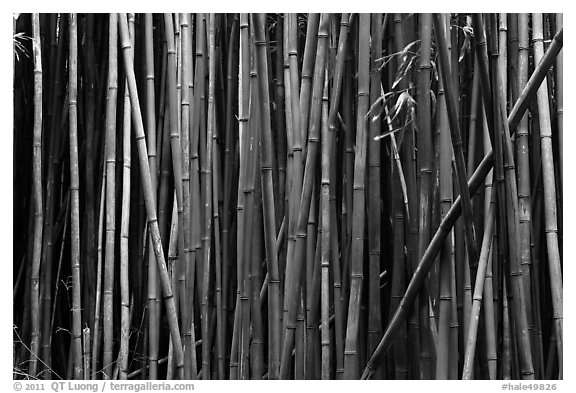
13;13;563;380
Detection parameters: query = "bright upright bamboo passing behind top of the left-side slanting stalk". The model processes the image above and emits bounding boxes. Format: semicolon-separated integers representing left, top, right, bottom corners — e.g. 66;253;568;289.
118;14;134;380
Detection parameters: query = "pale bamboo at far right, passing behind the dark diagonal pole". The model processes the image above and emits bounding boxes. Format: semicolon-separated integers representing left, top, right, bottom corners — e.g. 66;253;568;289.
532;14;564;379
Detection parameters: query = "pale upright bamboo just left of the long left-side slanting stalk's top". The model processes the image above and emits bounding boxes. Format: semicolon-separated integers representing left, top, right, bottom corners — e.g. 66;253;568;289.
102;14;118;379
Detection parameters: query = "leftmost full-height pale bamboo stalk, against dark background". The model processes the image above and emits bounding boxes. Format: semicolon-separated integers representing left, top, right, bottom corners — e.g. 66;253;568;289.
29;14;44;378
